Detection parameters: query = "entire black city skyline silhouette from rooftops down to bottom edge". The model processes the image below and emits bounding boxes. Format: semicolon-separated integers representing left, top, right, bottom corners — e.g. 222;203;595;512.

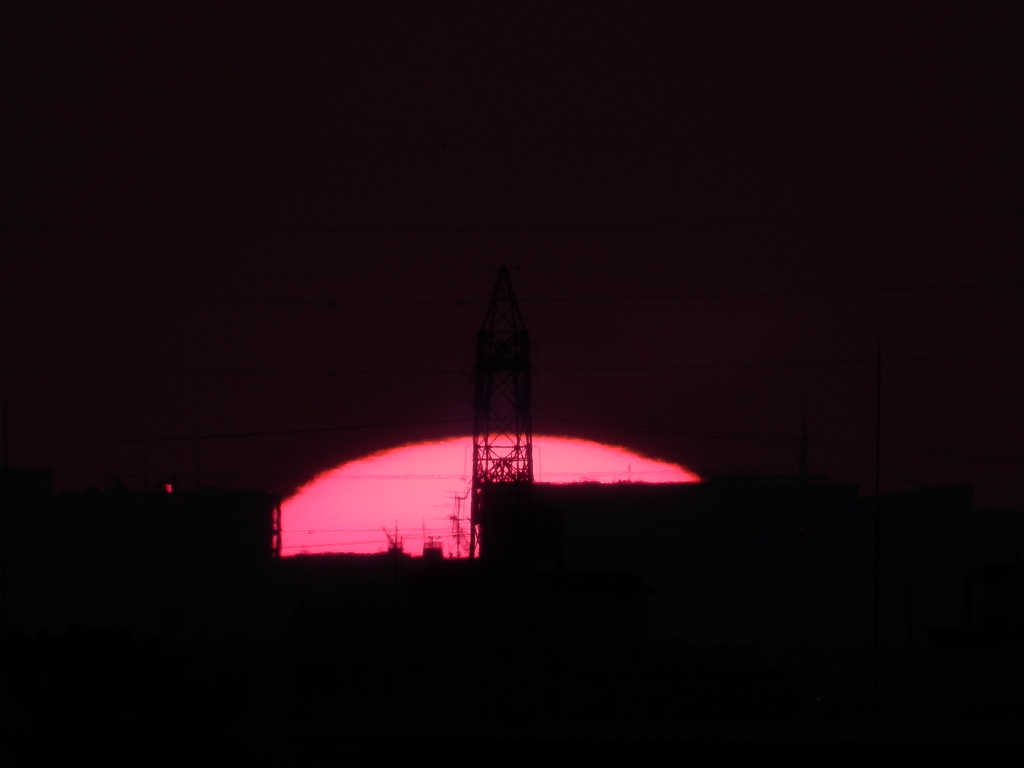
6;478;1024;765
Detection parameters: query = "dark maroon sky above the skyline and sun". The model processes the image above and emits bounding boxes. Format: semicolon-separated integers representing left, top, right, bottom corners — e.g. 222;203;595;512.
0;2;1024;506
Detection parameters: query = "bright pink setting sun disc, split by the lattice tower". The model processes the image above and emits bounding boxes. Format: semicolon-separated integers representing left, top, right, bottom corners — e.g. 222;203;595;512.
282;436;699;557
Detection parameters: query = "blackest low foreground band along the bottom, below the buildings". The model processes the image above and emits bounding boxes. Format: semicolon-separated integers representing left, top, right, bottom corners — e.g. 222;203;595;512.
0;627;1020;765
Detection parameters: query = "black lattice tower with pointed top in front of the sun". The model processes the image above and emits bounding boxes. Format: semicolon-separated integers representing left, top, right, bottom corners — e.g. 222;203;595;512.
469;266;534;562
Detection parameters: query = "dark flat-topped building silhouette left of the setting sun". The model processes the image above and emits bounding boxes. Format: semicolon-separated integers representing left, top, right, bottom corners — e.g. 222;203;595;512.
7;471;281;635
